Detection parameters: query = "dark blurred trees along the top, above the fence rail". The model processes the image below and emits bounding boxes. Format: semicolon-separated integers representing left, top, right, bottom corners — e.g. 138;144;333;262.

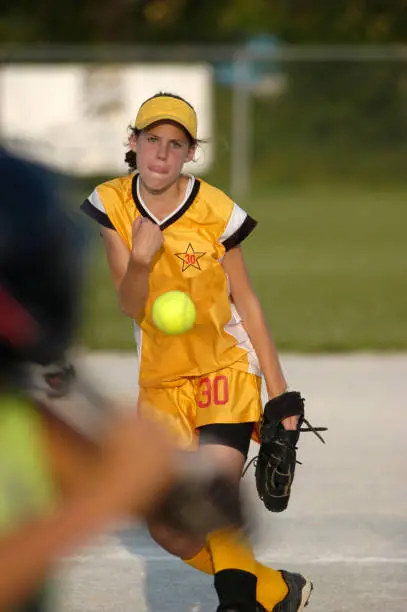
0;0;407;43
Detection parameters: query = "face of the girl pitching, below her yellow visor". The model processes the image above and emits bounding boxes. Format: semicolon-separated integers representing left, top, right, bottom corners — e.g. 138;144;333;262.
132;122;195;192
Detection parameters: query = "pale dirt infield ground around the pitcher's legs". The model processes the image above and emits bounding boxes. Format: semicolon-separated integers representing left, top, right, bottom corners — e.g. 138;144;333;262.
60;354;407;612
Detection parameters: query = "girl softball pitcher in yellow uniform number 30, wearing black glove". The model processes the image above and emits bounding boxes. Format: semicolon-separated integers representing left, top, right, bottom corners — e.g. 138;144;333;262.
82;93;326;612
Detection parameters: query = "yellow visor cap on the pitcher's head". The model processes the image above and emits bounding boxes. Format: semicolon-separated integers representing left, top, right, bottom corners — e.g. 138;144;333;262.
136;96;198;140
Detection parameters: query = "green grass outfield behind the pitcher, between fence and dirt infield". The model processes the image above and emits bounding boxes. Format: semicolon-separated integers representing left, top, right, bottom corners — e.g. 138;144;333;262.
81;180;407;352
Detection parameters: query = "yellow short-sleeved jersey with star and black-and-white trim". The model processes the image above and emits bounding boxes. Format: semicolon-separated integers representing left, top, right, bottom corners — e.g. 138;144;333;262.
81;173;260;387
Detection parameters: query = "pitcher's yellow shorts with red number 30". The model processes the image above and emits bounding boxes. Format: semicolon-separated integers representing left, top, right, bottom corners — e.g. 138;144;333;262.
138;368;261;447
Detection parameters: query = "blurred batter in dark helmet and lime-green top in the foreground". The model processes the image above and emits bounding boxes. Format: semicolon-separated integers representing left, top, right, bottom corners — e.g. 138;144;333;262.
0;151;242;612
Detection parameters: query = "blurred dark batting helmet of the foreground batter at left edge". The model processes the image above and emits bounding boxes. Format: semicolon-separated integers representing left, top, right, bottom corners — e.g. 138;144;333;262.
0;150;83;376
